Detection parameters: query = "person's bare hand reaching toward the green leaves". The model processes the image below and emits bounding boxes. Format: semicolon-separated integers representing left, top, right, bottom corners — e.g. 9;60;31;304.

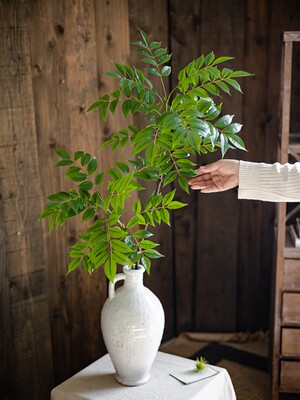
188;160;240;193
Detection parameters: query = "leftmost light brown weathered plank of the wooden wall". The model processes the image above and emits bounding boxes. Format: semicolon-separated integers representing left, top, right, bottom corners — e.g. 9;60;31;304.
0;1;53;400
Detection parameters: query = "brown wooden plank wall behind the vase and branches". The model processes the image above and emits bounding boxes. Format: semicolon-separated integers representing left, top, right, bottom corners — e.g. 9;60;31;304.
0;0;300;400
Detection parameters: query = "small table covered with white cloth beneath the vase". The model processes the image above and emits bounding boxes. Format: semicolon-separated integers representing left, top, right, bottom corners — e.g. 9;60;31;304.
51;352;236;400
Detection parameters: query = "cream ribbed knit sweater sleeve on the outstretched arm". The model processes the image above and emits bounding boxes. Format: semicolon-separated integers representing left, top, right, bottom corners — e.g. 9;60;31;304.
238;161;300;202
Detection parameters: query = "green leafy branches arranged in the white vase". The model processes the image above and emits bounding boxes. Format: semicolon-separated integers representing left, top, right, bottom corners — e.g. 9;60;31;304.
40;31;250;280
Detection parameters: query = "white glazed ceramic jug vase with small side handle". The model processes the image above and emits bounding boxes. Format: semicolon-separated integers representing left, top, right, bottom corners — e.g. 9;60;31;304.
101;267;165;386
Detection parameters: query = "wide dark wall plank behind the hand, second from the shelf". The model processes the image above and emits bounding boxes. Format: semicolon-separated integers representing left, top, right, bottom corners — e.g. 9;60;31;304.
195;0;246;331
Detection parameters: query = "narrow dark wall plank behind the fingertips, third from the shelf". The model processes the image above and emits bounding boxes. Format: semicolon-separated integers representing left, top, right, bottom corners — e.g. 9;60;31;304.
169;0;201;334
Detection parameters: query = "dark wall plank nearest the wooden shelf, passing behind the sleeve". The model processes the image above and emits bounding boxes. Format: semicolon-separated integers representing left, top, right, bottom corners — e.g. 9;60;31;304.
237;1;273;330
